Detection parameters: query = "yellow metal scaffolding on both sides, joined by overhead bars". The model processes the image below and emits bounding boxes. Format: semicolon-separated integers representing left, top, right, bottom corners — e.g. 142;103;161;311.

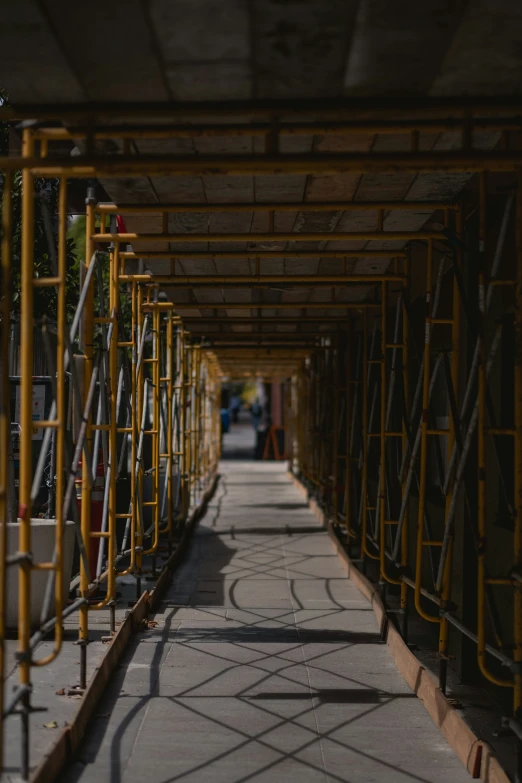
0;107;522;777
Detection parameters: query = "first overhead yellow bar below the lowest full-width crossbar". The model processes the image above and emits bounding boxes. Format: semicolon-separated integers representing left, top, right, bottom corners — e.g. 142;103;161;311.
96;201;458;215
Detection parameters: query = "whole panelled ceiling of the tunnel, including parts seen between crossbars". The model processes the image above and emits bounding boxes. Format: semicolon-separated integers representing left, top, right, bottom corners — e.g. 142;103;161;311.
0;0;522;376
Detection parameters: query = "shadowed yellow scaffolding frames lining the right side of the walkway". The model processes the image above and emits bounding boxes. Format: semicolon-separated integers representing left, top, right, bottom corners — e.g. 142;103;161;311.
292;188;522;763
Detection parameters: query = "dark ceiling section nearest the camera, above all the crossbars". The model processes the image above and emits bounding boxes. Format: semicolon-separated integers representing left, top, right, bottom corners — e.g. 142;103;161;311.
4;0;522;103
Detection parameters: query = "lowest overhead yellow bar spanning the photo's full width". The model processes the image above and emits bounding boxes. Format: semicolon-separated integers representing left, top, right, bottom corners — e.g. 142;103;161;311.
6;150;522;174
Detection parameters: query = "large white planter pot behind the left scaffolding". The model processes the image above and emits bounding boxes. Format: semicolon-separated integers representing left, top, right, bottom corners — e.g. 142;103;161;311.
6;519;74;628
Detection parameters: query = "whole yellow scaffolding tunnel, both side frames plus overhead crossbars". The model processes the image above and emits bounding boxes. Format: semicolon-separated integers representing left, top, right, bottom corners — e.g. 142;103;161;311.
0;102;522;778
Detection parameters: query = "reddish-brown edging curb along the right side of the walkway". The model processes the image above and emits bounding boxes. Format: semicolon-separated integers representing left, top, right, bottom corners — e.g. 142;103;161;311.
287;472;510;783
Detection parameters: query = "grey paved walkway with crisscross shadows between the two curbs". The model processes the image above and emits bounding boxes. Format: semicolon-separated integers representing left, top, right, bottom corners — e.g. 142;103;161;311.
63;430;470;783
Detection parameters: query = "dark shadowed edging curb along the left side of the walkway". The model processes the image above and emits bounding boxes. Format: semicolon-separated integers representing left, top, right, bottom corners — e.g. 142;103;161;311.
30;474;219;783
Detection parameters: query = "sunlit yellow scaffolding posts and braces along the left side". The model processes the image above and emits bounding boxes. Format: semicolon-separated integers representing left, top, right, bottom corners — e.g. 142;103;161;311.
0;147;220;779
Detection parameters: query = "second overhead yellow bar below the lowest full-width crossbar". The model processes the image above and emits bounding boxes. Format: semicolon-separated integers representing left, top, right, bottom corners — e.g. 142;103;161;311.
96;231;447;243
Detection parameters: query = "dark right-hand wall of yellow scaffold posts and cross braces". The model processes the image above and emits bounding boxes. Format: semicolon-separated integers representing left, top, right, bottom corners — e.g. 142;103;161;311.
290;190;522;752
